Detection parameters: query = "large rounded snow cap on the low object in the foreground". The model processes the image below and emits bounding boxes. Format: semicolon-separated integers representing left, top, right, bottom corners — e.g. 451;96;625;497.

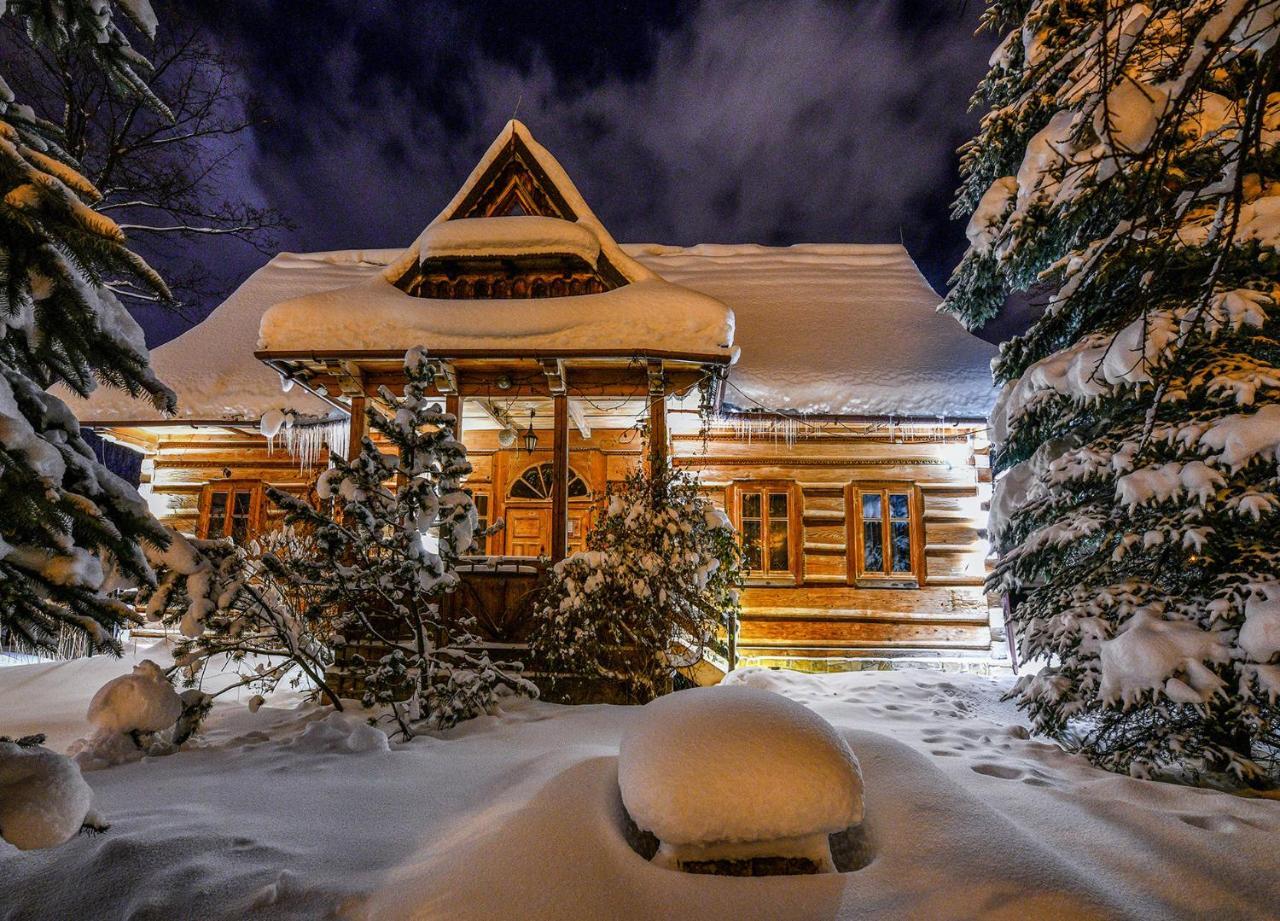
618;687;863;865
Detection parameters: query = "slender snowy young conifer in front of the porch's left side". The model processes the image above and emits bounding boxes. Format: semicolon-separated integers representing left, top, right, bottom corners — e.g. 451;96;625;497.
269;348;536;733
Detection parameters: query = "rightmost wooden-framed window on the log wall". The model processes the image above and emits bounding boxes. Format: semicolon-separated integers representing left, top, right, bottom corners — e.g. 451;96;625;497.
845;482;924;585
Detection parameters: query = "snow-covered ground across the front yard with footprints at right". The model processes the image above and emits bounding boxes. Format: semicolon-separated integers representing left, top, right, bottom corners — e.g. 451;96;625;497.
0;646;1280;920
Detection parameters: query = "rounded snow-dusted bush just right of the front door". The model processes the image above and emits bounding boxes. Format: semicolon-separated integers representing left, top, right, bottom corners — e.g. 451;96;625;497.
531;467;744;702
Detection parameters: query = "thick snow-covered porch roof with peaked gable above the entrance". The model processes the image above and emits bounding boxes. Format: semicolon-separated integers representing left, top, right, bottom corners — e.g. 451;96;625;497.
259;120;733;359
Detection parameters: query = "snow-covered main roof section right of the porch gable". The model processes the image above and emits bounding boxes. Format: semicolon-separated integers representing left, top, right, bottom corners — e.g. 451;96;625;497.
625;243;996;418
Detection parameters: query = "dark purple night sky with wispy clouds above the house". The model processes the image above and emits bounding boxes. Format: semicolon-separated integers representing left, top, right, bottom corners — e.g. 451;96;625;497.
152;0;995;345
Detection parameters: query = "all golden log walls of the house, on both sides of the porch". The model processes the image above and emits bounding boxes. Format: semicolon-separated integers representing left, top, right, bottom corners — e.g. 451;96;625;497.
104;414;992;669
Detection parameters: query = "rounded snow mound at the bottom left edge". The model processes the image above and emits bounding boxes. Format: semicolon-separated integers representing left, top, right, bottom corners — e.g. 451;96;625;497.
0;737;100;851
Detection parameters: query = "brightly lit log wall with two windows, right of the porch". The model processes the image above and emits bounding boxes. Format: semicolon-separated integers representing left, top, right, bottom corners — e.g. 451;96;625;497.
673;423;992;669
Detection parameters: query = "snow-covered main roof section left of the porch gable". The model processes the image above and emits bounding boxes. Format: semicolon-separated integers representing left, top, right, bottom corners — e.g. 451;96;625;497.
60;249;399;422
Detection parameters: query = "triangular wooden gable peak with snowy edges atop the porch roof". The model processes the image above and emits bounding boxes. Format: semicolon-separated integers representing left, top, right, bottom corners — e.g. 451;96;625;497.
385;119;655;284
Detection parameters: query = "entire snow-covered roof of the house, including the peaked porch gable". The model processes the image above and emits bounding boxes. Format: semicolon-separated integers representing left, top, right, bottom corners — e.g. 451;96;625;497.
70;115;996;422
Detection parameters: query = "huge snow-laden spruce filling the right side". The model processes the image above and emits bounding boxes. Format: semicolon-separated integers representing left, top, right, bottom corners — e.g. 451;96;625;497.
946;0;1280;783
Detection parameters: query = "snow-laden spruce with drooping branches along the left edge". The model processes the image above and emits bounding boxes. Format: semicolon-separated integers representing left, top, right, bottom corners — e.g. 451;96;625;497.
0;0;215;649
